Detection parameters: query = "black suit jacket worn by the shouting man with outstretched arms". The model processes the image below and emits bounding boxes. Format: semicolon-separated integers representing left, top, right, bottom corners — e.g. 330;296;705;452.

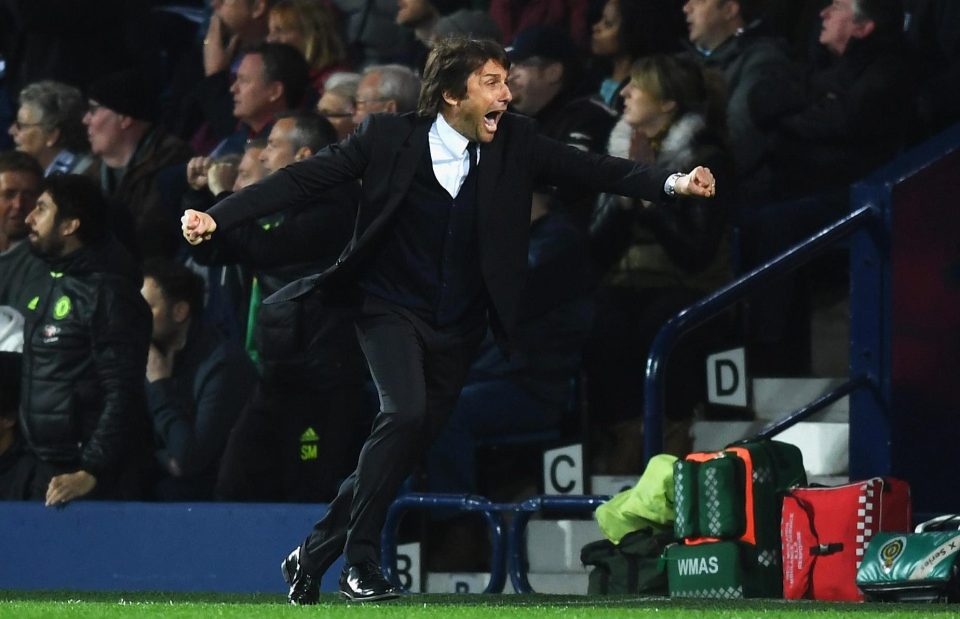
209;113;674;338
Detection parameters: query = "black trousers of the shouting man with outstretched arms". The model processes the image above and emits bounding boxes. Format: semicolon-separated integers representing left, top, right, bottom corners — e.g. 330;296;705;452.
301;297;486;576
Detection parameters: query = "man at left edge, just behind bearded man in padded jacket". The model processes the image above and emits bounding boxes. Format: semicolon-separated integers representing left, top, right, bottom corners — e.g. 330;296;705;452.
0;151;49;315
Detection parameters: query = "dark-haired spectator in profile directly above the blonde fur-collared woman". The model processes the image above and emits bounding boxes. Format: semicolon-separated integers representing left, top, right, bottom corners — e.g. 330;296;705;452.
590;0;685;112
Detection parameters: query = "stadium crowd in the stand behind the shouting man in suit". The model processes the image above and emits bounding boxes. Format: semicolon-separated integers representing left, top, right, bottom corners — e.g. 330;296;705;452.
0;0;960;506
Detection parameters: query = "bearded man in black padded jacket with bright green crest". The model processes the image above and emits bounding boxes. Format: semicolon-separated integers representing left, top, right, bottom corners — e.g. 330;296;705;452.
20;175;150;506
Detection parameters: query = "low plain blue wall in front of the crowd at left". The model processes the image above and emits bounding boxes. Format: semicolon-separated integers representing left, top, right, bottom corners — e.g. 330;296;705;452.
0;501;343;594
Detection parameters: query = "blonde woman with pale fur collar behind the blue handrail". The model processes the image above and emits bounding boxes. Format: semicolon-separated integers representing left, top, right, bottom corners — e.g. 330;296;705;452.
586;55;733;474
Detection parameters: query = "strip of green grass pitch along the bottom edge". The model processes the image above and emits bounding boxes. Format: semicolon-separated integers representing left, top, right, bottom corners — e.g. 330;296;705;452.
0;591;960;619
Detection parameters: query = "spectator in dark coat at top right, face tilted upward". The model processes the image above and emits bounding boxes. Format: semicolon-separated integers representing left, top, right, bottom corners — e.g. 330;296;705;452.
751;0;916;201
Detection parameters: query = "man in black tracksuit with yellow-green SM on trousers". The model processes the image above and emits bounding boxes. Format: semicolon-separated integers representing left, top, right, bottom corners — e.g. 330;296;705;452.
194;112;370;501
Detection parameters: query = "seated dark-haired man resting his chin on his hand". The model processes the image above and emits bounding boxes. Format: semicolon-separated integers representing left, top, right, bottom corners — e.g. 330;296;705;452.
140;260;257;501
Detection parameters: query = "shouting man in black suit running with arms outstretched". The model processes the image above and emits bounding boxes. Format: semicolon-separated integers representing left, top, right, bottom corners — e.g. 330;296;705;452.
183;39;714;604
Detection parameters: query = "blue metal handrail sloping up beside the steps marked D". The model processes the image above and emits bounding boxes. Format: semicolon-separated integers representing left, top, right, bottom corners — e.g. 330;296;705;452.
643;204;881;463
